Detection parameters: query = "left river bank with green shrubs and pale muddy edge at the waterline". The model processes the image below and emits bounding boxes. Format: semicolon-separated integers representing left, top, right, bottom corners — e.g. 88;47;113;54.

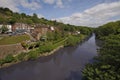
0;36;88;68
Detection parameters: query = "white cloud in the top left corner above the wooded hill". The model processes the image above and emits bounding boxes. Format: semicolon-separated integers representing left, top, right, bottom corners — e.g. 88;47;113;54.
0;0;19;12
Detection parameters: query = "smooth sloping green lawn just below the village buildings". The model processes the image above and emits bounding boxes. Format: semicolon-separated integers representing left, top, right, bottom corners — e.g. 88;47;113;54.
0;35;30;45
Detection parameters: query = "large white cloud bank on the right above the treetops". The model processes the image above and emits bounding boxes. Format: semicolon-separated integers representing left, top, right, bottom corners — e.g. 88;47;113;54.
57;1;120;27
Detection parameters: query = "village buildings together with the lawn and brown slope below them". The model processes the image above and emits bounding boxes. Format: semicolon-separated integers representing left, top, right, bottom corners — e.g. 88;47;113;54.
0;23;55;58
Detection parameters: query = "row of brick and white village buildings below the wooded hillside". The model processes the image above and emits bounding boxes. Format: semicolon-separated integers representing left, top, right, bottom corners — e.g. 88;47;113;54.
0;23;55;41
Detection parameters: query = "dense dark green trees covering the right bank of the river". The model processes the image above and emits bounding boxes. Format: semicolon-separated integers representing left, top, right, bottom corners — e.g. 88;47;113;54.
83;21;120;80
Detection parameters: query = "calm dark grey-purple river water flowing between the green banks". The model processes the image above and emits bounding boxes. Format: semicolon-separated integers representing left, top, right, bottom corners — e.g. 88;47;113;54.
0;34;98;80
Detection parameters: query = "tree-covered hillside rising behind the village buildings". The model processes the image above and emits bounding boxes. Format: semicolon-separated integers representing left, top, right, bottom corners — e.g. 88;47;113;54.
0;7;92;34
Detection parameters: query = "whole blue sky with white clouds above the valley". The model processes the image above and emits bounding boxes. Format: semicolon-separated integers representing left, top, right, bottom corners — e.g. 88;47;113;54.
0;0;120;27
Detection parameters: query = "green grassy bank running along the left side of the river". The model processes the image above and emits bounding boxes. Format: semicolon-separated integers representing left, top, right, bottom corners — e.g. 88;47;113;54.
0;35;86;67
